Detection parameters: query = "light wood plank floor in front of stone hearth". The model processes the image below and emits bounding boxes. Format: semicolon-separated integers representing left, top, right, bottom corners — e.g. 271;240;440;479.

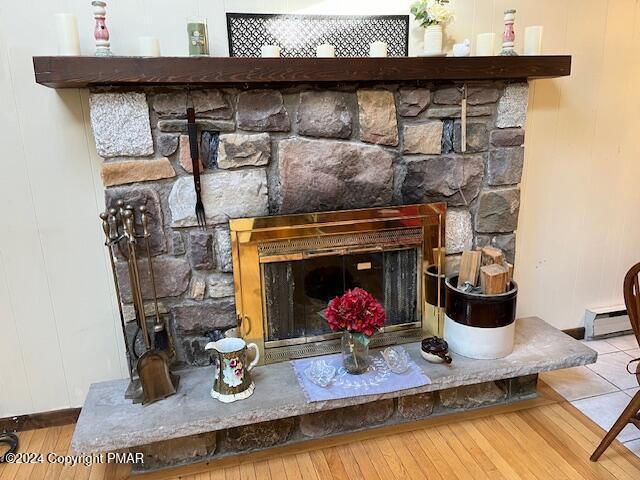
0;386;640;480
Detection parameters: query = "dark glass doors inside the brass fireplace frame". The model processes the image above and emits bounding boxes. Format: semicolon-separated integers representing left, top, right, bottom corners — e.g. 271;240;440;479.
262;247;420;347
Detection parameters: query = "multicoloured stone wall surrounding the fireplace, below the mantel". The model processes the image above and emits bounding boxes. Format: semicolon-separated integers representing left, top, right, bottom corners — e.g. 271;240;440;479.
90;81;528;366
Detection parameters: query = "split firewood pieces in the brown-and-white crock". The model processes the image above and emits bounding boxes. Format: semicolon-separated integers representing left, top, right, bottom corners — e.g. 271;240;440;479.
458;247;513;295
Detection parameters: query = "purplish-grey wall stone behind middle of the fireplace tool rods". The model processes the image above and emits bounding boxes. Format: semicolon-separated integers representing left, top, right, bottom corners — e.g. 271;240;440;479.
116;257;191;303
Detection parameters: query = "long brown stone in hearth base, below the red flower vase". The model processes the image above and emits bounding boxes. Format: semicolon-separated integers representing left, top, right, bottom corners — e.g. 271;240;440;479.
300;398;394;438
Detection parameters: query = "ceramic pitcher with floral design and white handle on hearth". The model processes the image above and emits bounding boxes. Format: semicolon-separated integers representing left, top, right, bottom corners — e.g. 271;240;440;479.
204;337;260;403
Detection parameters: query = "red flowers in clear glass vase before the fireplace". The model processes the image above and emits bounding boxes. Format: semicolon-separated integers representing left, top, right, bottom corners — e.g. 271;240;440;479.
325;288;387;374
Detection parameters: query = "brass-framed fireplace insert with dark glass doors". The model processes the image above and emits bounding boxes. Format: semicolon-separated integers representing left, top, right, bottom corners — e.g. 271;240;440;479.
230;203;446;363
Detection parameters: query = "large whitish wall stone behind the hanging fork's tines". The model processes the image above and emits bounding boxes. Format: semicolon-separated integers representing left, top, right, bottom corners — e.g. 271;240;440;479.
169;169;268;227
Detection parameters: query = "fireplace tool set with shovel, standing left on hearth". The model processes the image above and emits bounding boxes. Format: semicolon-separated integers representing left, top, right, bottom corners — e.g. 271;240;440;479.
100;200;180;404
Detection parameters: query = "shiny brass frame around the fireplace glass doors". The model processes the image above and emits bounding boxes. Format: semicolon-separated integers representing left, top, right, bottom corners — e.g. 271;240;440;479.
229;203;446;363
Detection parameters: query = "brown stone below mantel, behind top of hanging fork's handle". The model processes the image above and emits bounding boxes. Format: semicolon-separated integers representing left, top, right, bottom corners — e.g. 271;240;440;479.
152;90;233;119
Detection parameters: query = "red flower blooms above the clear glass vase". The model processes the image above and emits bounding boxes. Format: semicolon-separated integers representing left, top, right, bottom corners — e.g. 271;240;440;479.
325;288;387;337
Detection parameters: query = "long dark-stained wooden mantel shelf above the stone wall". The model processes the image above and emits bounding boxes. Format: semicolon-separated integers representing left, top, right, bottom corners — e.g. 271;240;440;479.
33;55;571;88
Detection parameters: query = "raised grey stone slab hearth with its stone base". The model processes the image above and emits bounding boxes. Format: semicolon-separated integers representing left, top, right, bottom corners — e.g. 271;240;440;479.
72;318;597;472
